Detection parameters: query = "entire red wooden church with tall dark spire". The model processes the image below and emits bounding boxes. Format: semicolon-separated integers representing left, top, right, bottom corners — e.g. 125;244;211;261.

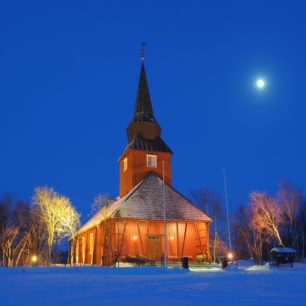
69;56;212;265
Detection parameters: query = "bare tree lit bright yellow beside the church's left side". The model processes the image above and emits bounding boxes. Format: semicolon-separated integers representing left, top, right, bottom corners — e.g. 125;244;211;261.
33;187;80;263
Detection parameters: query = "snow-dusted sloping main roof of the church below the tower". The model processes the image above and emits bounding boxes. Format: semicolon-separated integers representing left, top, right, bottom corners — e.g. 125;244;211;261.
79;172;211;232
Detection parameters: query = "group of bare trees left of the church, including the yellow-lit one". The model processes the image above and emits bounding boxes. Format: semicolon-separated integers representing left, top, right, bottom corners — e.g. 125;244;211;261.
0;187;80;267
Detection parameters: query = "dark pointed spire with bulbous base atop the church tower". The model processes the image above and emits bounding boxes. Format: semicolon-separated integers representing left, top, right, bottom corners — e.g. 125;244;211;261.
127;61;161;143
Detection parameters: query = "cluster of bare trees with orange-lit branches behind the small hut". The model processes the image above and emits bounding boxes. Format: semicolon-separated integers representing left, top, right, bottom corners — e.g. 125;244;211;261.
234;182;306;263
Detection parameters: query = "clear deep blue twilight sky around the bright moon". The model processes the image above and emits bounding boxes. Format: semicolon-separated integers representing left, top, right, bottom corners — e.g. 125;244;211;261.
0;0;306;221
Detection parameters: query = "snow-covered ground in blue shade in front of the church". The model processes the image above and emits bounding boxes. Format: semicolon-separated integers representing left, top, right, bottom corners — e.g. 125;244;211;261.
0;264;306;306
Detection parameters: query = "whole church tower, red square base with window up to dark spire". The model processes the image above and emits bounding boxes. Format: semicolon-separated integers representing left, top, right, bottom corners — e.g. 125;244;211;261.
119;56;172;197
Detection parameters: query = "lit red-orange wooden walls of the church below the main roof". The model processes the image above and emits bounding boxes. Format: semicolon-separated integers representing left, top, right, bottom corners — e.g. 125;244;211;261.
71;219;210;265
